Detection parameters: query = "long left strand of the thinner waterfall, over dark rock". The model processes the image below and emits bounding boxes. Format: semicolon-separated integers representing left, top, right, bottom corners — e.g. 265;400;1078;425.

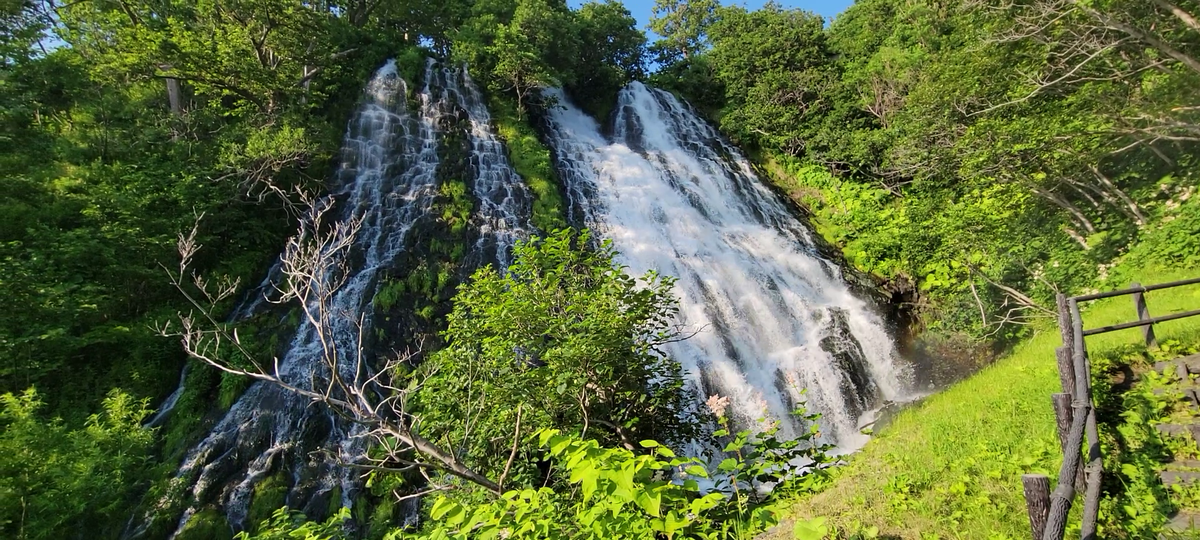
154;57;446;529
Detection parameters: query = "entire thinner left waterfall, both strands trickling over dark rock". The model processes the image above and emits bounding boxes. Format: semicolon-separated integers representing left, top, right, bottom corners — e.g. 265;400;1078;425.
141;59;529;536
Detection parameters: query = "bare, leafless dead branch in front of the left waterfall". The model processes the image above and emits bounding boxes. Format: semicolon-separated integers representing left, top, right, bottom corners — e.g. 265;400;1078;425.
158;199;501;494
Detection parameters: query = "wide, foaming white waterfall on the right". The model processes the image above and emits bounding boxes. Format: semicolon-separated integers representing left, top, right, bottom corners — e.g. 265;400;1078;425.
546;83;906;450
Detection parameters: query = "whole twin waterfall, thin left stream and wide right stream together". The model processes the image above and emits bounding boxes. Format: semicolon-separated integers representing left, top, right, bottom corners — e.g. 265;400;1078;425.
150;60;908;536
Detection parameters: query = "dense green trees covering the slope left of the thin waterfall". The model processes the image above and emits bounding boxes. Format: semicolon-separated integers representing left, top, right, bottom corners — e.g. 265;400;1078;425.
0;1;415;538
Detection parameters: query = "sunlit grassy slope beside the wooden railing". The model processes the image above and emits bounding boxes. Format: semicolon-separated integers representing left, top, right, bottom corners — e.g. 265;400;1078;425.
766;264;1200;539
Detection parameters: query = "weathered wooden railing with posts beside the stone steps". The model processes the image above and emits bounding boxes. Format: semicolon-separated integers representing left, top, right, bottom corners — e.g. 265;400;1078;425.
1021;277;1200;540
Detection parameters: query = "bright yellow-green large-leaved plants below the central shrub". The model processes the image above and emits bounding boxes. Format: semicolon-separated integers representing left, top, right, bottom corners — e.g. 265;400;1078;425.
398;422;826;540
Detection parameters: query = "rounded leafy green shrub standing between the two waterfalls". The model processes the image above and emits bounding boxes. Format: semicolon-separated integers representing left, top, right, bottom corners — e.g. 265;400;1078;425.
420;230;692;479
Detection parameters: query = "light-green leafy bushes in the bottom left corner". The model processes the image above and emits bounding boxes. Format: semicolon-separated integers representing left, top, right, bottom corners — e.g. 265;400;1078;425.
0;389;154;539
